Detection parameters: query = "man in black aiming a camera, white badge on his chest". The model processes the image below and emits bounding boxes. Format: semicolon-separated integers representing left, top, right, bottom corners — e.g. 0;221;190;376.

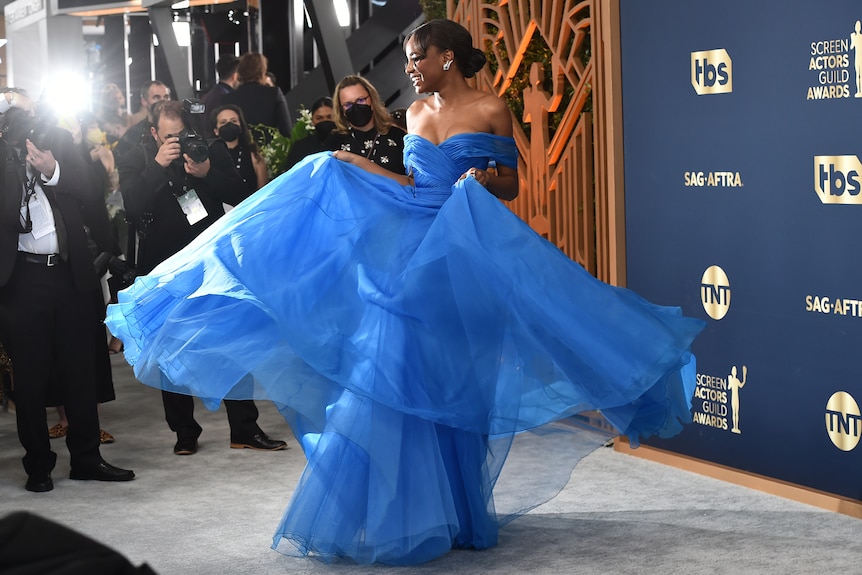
119;100;287;455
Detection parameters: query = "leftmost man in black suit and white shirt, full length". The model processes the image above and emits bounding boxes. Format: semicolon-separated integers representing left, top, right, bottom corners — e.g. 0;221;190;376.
0;91;135;492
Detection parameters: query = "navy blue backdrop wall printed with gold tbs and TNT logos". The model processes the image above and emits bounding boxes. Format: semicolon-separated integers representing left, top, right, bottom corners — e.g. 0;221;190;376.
620;0;862;500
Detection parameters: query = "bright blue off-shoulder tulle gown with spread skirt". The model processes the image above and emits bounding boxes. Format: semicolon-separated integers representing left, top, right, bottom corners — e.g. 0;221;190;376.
107;134;703;564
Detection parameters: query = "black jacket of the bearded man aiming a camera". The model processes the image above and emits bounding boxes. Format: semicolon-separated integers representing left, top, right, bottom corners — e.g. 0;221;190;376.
118;138;248;274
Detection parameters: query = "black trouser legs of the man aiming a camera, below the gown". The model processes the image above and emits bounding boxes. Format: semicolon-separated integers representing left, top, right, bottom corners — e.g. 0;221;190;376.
162;391;261;442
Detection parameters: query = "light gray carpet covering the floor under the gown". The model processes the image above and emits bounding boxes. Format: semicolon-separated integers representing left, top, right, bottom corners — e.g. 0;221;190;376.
0;356;862;575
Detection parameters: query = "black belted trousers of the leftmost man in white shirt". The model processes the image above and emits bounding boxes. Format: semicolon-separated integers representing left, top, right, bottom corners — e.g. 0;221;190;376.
0;262;102;475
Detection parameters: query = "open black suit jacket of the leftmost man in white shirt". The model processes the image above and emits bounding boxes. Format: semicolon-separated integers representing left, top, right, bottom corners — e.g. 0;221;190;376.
0;128;104;291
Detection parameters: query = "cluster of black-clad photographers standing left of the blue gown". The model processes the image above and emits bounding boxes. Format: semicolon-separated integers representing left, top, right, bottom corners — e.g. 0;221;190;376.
0;58;294;492
